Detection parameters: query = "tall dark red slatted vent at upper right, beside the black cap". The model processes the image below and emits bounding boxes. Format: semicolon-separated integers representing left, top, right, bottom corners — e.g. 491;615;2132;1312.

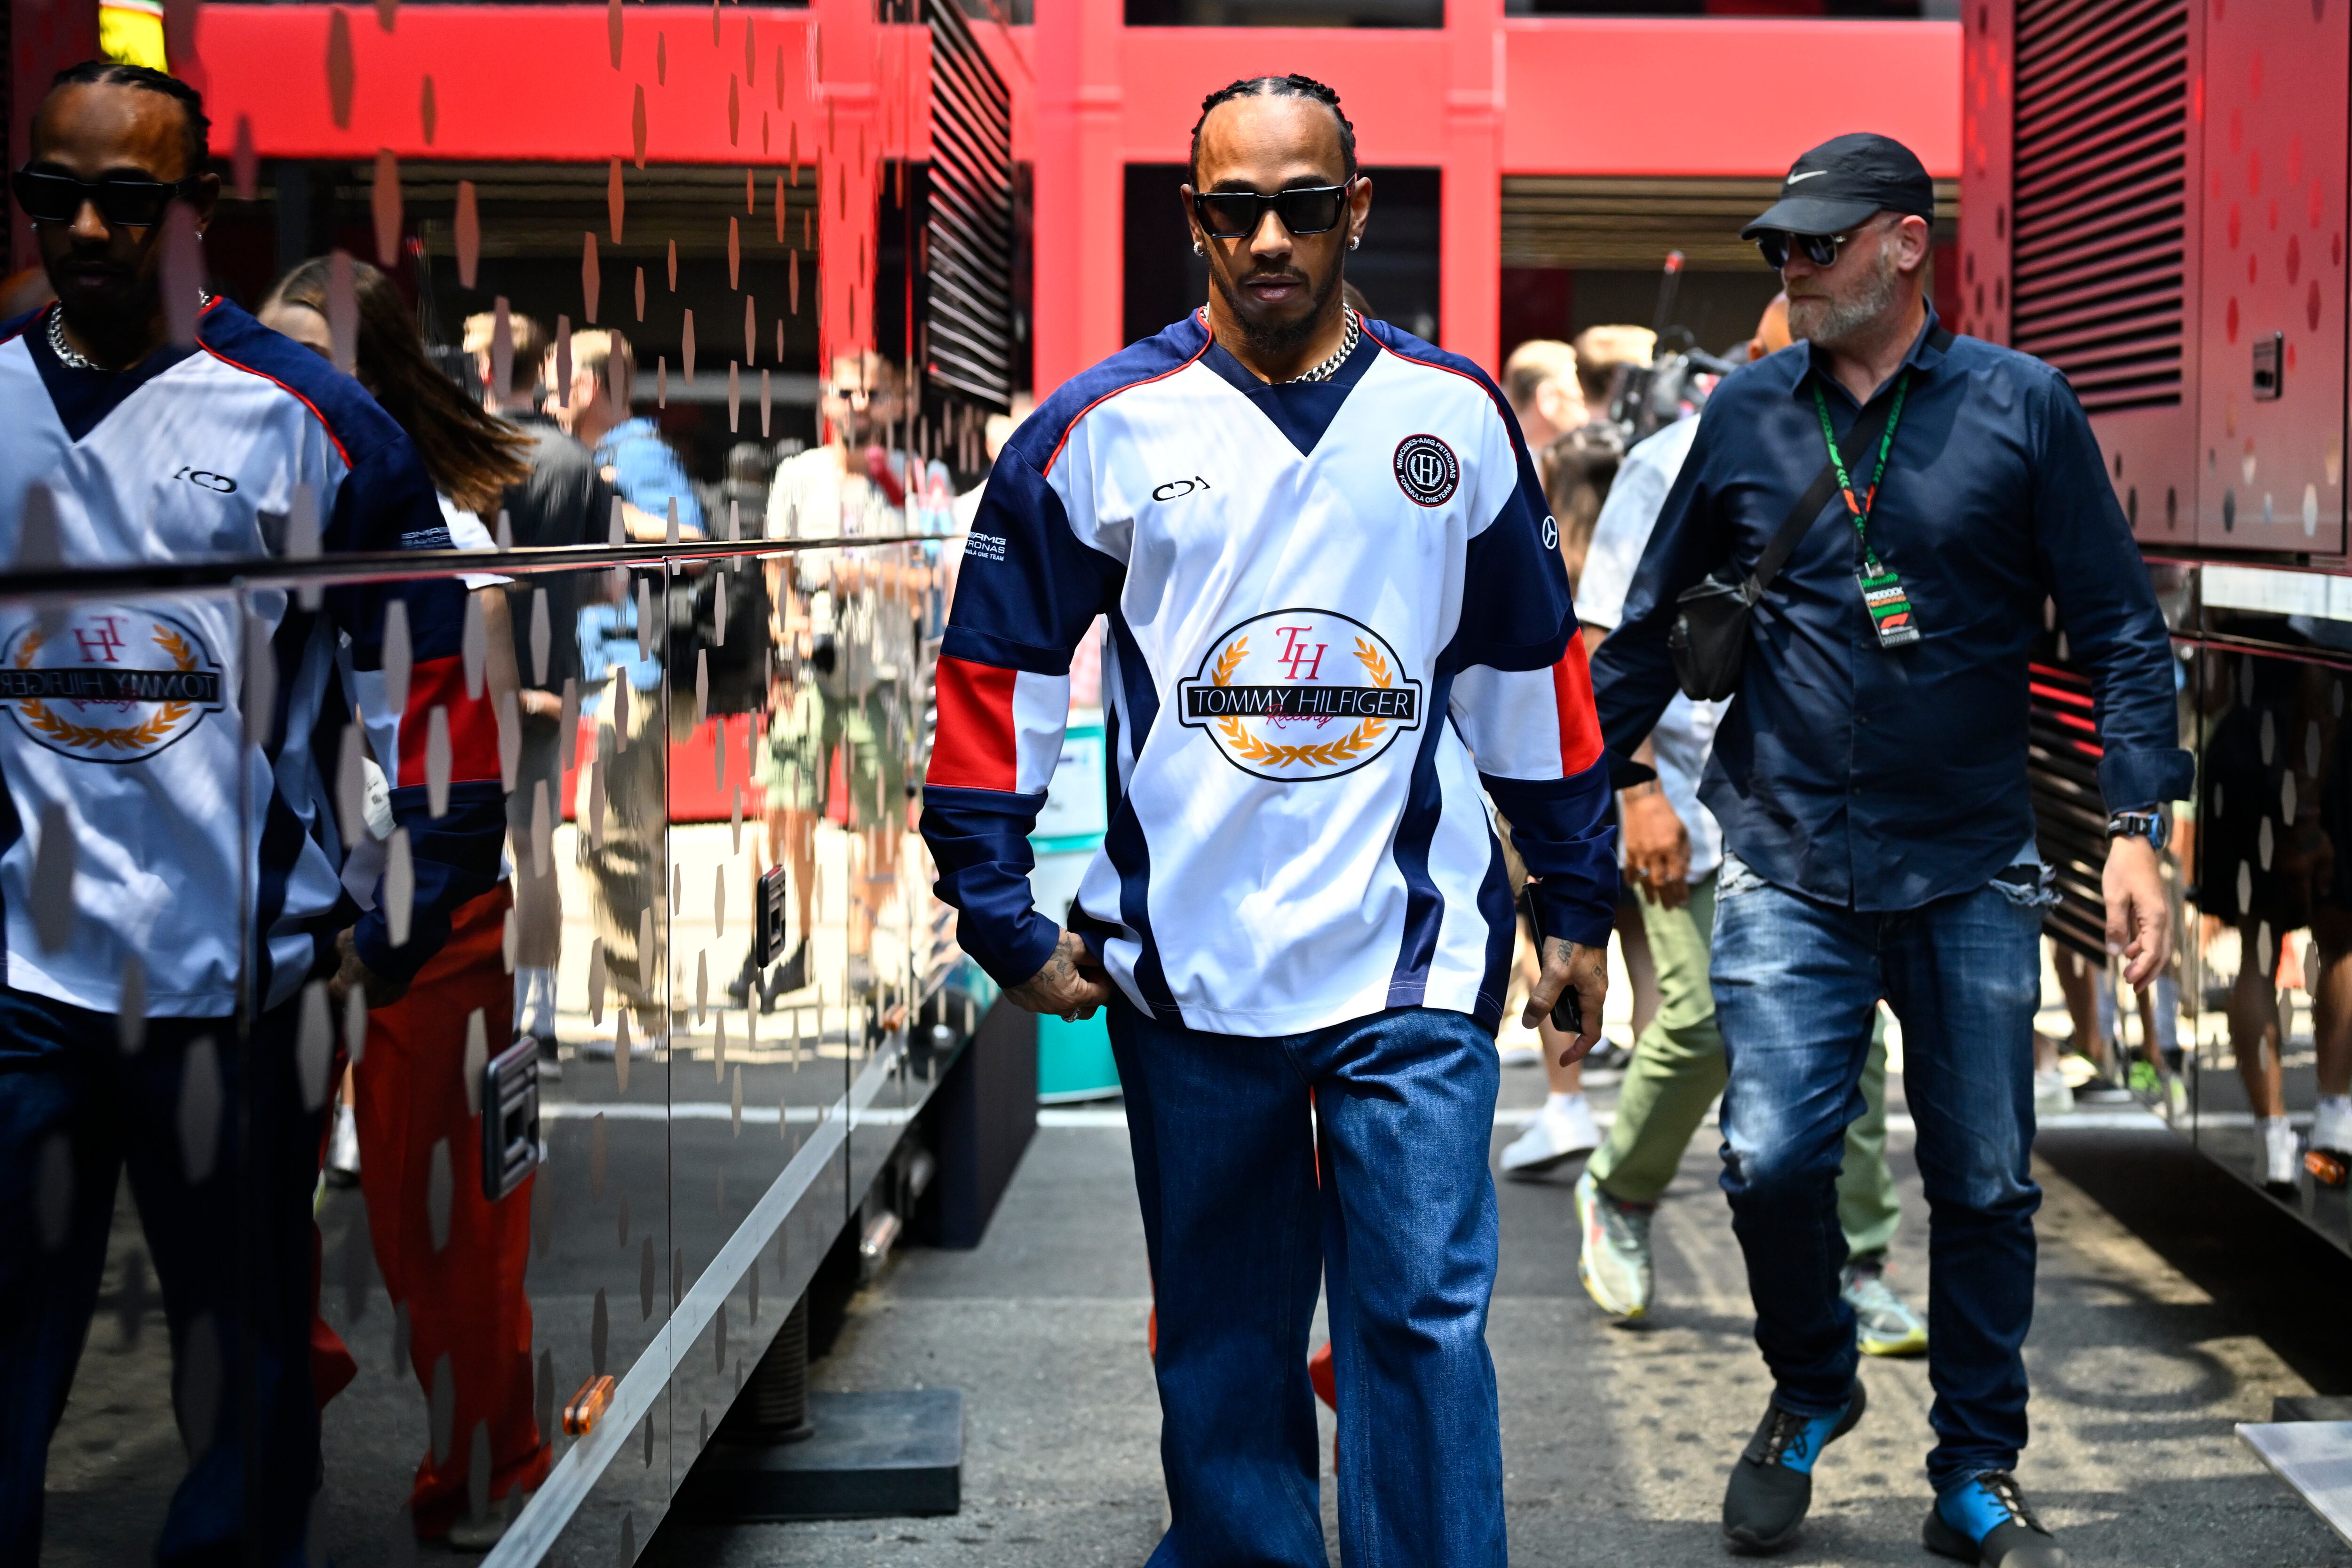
2009;0;2190;414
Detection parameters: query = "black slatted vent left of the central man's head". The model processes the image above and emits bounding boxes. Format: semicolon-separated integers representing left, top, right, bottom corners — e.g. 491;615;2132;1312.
924;0;1014;409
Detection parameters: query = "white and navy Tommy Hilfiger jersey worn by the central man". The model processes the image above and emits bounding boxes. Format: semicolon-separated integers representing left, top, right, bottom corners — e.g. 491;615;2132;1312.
922;315;1616;1034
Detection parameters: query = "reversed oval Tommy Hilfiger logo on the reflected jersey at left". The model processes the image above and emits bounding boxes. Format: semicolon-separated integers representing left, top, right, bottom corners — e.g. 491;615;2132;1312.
0;604;223;762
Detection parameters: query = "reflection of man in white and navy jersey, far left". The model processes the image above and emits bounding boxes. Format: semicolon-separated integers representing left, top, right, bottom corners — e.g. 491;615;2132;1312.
0;61;506;1563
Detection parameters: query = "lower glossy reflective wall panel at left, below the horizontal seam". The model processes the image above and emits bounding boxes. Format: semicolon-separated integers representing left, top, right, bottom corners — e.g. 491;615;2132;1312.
0;529;960;1563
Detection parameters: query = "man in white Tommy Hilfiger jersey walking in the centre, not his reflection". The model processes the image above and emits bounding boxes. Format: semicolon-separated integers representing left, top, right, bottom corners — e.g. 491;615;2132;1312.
922;75;1616;1568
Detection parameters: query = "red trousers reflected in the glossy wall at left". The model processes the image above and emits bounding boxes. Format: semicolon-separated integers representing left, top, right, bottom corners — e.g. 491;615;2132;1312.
353;884;553;1540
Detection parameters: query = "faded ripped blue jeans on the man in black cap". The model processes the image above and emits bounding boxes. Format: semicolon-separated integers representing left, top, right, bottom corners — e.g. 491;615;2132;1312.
1712;863;2042;1490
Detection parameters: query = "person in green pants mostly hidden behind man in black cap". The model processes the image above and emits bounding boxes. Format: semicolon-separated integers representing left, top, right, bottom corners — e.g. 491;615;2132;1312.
1576;299;1926;1356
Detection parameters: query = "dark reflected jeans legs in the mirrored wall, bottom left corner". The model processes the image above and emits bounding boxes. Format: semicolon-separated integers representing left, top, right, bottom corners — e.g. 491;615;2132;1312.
0;990;322;1568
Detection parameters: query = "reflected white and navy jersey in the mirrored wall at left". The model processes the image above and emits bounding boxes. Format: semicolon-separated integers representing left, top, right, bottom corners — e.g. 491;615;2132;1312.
0;301;506;1018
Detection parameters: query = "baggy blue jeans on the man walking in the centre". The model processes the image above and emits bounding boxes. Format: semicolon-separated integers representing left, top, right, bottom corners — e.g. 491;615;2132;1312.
1110;999;1505;1568
